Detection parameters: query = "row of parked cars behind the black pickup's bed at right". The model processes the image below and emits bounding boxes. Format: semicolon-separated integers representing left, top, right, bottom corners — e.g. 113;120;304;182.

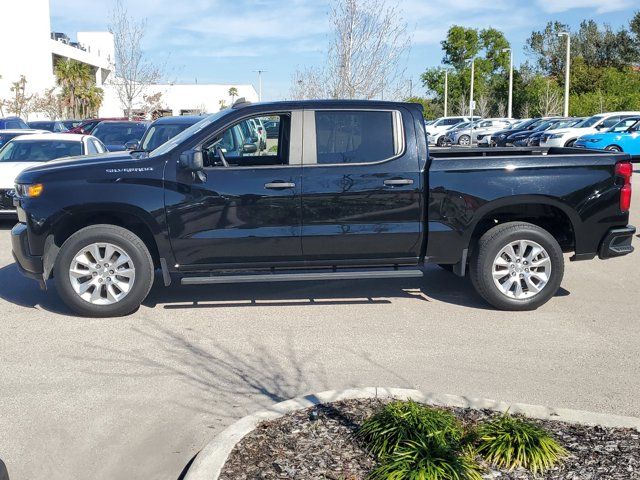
425;111;640;155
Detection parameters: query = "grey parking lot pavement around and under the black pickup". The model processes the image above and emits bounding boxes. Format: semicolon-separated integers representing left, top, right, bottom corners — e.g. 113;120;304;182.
0;182;640;480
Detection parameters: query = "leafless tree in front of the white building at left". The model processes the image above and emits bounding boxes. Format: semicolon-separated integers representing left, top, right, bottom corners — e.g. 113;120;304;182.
109;0;162;118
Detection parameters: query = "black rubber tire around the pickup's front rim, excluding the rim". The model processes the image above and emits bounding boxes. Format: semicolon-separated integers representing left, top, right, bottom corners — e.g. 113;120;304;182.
54;225;154;317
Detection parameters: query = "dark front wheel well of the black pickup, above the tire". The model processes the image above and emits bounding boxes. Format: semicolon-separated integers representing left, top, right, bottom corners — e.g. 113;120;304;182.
53;212;160;268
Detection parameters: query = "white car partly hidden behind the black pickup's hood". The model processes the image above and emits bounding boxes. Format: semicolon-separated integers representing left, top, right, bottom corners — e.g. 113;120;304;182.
0;133;107;216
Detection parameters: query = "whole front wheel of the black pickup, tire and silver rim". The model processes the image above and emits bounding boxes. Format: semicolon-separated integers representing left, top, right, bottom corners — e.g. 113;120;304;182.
54;225;154;317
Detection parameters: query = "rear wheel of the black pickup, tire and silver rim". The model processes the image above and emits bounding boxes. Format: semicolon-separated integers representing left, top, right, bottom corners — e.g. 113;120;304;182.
470;222;564;311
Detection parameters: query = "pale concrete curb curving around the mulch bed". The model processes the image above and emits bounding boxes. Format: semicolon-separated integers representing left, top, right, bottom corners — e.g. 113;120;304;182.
184;387;640;480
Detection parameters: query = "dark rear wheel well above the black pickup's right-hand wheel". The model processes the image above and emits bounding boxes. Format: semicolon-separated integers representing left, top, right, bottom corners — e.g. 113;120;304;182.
469;204;575;252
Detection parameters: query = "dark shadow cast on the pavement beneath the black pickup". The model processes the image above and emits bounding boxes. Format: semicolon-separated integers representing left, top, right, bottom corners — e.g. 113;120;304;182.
0;264;569;316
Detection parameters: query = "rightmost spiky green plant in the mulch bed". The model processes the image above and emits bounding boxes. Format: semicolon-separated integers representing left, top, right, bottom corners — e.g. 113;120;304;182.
476;414;567;474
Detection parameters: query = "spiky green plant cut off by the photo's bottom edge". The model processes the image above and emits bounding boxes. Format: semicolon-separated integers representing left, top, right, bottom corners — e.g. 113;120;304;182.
370;438;482;480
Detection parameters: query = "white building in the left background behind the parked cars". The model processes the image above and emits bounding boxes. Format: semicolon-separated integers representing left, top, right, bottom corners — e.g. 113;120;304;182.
0;0;258;120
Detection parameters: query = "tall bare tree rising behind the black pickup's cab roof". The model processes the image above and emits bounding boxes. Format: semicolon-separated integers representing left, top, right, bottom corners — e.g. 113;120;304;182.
291;0;410;99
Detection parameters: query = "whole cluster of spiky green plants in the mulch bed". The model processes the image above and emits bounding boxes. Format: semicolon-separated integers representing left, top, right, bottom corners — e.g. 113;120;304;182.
357;401;566;480
